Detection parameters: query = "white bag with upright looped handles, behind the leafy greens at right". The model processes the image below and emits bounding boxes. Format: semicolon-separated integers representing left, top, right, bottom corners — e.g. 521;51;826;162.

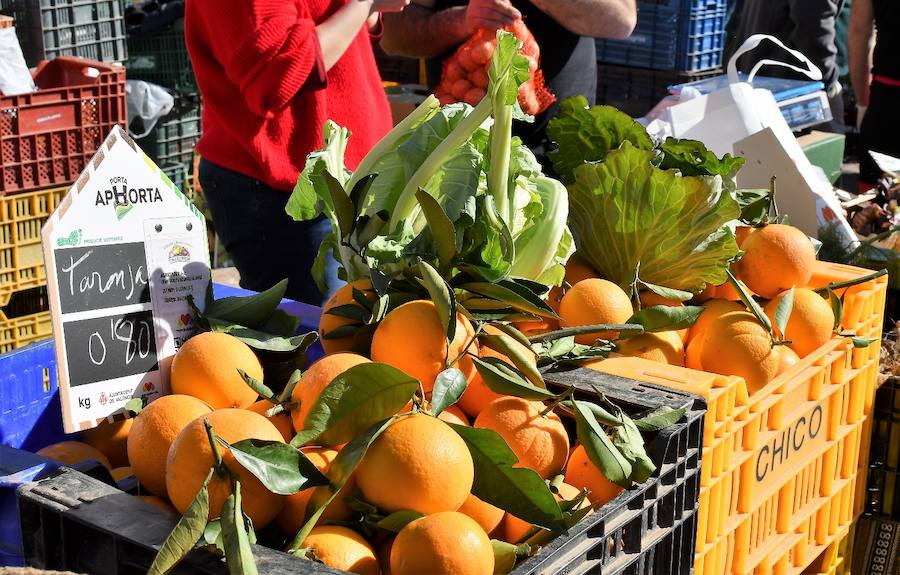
667;34;822;157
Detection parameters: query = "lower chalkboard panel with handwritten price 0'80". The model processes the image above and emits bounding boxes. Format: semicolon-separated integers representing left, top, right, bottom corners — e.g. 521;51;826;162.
63;311;157;387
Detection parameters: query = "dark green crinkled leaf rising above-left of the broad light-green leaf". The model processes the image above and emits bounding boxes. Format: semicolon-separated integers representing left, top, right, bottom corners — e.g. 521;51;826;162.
547;96;653;183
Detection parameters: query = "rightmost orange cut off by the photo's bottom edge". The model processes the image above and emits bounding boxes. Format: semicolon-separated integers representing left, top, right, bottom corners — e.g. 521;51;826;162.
391;511;494;575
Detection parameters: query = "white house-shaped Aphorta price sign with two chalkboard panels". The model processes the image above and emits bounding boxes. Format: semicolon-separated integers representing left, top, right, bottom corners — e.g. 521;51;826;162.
42;127;210;433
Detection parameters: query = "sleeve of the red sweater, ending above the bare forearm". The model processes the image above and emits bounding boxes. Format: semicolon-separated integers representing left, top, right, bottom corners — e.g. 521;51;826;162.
202;0;325;116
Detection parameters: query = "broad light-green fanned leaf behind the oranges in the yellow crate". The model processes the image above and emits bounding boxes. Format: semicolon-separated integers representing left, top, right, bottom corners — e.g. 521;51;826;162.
569;141;740;291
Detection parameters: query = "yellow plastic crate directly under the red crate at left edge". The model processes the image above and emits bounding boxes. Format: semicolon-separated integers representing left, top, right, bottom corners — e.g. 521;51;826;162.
0;187;69;308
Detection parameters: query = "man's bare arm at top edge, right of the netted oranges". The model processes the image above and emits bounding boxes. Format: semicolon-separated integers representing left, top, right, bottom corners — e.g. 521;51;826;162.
531;0;637;38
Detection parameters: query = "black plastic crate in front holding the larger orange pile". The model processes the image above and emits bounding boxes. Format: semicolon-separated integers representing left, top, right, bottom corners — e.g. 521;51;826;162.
12;369;706;575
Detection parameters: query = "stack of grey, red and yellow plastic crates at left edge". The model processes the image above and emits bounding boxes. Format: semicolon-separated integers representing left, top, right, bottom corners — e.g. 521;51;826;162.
0;6;126;353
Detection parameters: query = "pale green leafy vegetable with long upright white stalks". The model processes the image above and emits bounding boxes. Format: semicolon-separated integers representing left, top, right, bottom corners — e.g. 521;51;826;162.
286;31;574;295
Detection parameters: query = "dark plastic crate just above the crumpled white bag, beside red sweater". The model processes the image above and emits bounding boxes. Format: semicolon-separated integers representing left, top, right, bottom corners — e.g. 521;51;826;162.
128;18;197;94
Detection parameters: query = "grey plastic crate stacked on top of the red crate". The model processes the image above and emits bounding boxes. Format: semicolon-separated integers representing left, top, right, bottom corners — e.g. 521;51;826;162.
4;0;128;67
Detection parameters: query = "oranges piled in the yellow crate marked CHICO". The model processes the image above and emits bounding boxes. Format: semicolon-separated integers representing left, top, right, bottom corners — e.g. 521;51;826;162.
559;224;835;393
